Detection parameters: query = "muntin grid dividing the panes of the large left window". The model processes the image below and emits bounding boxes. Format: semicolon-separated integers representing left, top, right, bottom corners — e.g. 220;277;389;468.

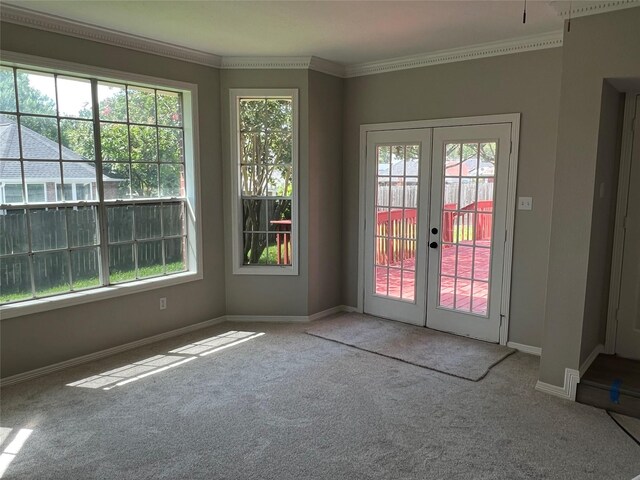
0;65;190;305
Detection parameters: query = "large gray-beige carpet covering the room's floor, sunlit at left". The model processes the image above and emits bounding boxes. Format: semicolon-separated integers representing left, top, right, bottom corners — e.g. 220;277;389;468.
0;323;640;480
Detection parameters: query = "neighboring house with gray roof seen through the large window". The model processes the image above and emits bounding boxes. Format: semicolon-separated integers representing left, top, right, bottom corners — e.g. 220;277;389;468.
0;115;119;204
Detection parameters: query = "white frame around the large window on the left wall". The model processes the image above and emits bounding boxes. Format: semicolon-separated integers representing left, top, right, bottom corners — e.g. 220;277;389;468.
0;50;203;320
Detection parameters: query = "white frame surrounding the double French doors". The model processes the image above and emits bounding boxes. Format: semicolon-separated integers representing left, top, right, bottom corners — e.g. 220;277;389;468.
357;113;520;345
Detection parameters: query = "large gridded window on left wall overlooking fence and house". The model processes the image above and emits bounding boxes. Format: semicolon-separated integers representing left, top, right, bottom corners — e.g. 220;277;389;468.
0;59;197;304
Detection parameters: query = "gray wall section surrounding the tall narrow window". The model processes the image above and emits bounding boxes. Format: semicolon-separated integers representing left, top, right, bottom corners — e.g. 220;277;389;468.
220;70;309;315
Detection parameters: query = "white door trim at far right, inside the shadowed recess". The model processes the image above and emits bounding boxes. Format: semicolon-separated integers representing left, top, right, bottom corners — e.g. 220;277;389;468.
604;92;640;355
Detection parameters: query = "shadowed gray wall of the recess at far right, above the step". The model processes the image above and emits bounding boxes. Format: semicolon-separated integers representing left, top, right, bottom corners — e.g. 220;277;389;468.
580;80;624;364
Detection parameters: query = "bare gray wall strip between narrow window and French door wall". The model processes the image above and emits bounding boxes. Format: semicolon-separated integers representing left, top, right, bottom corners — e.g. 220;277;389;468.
309;71;344;314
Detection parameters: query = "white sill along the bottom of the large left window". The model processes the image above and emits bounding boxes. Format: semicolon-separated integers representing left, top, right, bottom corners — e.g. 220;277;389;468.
0;272;202;320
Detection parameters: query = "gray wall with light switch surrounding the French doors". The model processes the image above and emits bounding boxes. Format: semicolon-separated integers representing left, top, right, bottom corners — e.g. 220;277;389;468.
343;49;562;346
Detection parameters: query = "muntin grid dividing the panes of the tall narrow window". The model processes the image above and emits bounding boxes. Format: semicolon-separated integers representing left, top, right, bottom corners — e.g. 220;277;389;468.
235;95;297;268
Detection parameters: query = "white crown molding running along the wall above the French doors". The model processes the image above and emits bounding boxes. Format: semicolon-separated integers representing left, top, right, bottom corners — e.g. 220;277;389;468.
345;31;562;78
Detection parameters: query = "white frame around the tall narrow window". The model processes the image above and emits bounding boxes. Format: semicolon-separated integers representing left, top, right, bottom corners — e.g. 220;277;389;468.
229;88;300;275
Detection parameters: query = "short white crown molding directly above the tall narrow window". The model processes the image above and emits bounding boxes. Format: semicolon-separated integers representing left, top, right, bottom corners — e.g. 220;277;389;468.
220;56;344;77
